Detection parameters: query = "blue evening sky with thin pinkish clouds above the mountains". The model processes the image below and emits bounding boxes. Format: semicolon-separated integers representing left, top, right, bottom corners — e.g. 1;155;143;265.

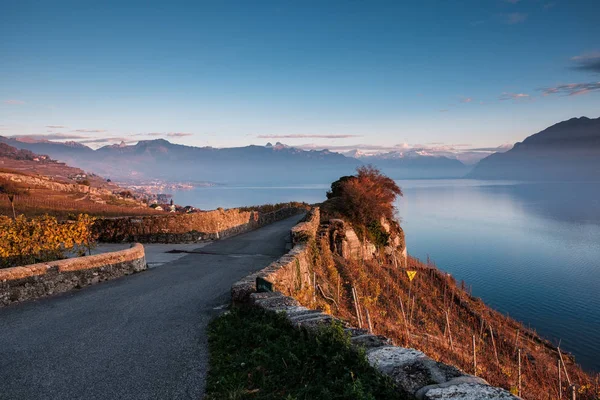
0;0;600;161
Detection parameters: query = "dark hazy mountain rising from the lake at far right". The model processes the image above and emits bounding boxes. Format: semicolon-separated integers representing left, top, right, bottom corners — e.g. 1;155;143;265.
468;117;600;181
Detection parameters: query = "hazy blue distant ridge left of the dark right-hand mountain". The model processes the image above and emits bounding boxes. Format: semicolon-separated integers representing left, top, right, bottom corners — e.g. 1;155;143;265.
0;137;466;185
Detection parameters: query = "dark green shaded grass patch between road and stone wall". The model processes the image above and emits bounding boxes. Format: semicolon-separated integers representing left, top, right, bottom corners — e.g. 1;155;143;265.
206;308;401;400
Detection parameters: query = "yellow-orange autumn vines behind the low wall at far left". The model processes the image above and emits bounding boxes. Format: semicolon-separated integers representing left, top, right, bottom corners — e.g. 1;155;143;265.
0;214;95;268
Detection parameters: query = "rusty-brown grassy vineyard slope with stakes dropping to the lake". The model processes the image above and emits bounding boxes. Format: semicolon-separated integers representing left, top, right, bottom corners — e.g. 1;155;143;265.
308;241;597;400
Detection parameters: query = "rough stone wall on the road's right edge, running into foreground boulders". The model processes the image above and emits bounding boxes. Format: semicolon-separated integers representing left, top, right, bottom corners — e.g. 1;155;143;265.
231;209;518;400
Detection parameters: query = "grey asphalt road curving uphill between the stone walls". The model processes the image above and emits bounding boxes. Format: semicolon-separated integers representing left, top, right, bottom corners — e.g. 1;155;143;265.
0;216;301;400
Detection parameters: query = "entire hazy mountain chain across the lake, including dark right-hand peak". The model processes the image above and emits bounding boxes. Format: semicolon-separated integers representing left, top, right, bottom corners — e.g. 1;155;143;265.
0;117;600;185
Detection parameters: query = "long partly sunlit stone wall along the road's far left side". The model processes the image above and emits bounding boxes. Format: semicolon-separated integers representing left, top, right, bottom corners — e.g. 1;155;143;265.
94;207;306;243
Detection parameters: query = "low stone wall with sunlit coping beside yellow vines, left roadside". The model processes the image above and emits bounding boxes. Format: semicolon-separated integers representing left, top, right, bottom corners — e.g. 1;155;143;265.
0;244;146;307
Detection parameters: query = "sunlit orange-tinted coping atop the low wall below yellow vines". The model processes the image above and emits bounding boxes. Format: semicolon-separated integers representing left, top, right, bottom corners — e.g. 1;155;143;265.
0;243;145;282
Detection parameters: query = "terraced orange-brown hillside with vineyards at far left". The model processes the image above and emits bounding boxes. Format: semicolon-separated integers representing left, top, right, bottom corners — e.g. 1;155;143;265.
0;143;158;217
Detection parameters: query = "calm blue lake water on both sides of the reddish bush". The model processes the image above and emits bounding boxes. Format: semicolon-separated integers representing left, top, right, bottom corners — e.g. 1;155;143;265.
174;180;600;371
